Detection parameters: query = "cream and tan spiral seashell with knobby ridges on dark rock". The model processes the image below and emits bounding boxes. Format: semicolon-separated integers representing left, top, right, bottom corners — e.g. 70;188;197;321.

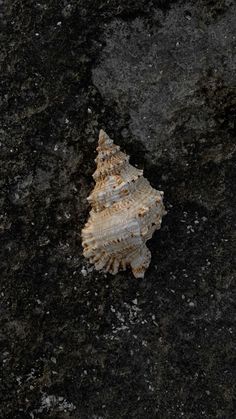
82;130;166;278
